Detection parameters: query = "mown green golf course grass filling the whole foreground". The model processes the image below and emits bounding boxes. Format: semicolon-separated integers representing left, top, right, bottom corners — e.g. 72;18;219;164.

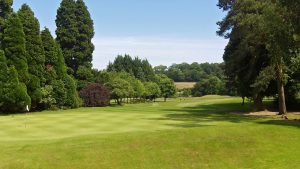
0;96;300;169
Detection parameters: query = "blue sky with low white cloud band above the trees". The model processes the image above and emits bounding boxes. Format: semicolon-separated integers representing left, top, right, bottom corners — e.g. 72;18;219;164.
14;0;227;69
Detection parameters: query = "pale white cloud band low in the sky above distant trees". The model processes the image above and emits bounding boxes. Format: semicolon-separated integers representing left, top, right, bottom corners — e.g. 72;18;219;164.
93;37;227;69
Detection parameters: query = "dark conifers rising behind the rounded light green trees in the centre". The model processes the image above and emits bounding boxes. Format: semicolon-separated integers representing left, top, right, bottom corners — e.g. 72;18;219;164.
107;54;155;81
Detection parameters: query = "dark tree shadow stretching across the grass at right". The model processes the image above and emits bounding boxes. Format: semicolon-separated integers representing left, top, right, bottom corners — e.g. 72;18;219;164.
150;103;300;128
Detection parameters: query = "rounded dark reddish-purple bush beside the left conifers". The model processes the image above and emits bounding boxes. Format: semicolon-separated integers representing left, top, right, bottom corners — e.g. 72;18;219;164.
79;83;110;107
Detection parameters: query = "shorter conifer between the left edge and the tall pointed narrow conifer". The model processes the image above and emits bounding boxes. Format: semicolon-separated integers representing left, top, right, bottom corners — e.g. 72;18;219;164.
2;14;29;84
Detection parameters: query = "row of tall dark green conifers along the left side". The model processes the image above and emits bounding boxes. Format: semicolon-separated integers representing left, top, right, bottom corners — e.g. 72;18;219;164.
0;0;94;112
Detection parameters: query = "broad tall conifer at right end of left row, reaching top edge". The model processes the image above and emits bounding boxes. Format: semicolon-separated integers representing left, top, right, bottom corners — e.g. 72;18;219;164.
56;0;94;83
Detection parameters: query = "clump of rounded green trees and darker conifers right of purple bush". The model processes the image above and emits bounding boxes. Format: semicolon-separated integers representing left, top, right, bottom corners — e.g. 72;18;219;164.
93;54;176;105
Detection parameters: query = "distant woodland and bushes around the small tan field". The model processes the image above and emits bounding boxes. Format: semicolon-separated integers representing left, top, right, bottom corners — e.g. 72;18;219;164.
154;62;237;97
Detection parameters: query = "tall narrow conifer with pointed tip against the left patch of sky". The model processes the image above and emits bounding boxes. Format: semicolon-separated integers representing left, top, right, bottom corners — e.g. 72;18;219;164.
18;4;45;109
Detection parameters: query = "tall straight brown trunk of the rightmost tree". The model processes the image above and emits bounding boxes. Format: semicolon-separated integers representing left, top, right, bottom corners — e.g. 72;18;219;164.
276;64;287;115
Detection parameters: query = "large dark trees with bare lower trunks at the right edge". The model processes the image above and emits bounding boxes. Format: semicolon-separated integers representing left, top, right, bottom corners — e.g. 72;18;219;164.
217;0;300;114
